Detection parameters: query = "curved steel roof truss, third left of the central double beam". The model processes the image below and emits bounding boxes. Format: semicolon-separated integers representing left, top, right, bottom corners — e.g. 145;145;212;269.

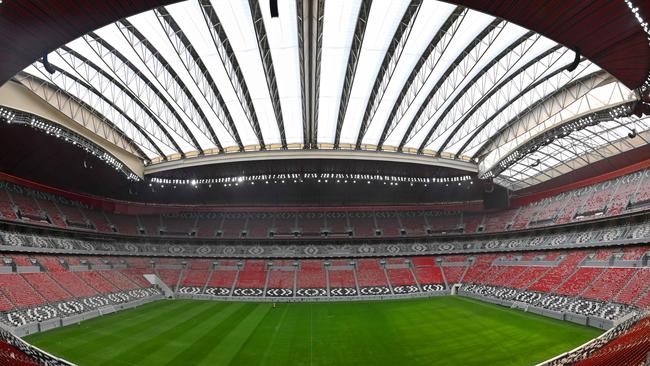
154;7;244;150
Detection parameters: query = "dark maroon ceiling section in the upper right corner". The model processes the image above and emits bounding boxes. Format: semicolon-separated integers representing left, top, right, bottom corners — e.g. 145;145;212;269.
450;0;650;89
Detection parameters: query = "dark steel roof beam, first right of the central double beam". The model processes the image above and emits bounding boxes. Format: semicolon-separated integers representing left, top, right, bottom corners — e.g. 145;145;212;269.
334;0;372;149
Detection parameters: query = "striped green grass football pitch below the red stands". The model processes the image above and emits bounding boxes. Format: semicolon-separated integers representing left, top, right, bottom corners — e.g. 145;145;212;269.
26;297;600;366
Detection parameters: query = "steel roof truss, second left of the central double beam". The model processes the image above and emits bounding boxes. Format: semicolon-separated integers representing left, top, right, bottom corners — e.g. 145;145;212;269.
199;0;266;149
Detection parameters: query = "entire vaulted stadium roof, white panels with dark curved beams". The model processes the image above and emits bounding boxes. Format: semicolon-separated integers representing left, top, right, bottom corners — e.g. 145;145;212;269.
1;0;650;189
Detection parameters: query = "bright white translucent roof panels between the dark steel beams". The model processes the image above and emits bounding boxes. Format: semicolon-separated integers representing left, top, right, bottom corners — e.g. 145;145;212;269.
16;0;646;186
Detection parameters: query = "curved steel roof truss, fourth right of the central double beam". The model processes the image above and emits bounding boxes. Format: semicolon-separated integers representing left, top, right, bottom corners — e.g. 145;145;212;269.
399;19;506;153
